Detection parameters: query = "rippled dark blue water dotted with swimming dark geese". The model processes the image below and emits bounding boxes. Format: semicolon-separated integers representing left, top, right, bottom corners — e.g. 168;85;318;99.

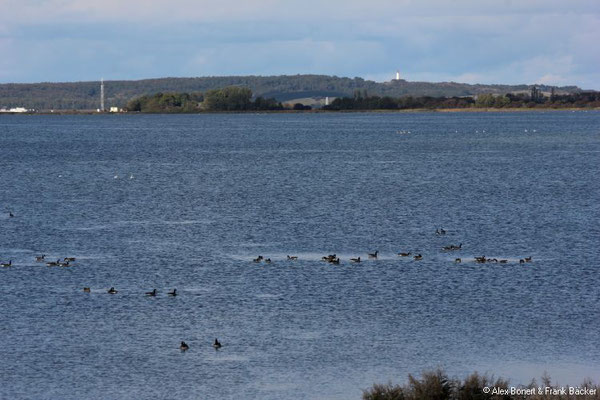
0;112;600;399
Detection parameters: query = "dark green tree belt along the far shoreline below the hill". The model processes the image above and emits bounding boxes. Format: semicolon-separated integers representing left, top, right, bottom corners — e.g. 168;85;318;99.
3;86;600;114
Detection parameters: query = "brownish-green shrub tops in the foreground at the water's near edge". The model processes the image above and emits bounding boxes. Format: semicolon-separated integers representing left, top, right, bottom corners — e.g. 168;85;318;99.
362;369;600;400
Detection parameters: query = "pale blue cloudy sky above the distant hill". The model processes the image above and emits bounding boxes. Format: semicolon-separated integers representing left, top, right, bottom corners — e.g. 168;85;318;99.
0;0;600;90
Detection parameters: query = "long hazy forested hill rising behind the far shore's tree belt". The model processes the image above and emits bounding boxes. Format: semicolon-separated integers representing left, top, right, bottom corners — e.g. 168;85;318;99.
0;75;581;110
